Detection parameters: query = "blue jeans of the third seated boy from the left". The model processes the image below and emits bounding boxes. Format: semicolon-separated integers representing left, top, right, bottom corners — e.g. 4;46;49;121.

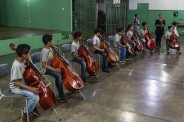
72;58;86;79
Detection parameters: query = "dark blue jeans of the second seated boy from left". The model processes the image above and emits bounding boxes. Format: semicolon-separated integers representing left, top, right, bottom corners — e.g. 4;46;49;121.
45;70;64;99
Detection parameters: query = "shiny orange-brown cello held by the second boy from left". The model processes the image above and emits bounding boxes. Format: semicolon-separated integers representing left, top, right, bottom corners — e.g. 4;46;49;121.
51;47;84;93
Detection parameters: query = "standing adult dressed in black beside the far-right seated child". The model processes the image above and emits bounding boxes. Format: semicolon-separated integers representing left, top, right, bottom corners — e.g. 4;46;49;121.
155;14;166;47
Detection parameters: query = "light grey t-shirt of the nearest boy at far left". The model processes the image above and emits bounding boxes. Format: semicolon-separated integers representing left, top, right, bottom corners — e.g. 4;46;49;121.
9;59;25;94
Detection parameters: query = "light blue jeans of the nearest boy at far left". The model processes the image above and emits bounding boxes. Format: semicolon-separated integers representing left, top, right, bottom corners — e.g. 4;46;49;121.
20;89;39;113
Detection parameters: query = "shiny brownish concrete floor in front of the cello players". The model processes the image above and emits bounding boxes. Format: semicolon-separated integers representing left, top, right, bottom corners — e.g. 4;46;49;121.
0;38;184;122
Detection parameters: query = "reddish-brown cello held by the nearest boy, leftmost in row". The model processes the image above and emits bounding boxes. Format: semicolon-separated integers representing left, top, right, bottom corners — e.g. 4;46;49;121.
10;43;57;110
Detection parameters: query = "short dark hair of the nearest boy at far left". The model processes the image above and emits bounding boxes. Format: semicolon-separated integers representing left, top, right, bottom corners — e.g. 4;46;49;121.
16;44;31;57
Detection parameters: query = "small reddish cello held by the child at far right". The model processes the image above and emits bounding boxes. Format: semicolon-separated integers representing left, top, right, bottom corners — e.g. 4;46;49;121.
169;33;180;49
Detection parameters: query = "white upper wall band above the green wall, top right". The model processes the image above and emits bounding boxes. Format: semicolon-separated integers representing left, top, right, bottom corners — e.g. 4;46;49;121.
129;0;184;10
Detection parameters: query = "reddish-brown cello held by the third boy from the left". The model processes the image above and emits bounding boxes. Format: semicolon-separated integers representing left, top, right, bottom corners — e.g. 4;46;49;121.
78;39;98;74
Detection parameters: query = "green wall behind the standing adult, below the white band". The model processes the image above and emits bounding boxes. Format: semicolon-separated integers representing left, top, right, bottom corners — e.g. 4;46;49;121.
127;3;184;34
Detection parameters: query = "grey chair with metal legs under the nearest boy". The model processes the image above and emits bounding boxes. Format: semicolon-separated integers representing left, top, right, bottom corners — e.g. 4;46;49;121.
0;64;29;122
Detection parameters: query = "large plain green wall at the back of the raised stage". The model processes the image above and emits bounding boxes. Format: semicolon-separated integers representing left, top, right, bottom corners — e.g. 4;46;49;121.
0;0;72;32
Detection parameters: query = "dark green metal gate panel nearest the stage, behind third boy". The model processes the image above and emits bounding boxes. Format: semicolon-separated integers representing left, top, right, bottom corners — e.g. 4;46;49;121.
73;0;98;38
